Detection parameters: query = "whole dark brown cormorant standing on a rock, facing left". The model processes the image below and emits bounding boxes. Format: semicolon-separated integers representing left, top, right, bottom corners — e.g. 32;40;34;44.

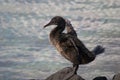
44;16;104;80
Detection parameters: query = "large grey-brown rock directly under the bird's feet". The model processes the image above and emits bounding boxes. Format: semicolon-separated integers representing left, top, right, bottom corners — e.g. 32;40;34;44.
45;67;84;80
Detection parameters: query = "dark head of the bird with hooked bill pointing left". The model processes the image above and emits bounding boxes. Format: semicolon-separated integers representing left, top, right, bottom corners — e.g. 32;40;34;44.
44;16;65;28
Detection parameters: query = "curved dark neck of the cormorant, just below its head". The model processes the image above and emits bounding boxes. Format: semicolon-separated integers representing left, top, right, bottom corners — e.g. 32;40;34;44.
50;24;65;38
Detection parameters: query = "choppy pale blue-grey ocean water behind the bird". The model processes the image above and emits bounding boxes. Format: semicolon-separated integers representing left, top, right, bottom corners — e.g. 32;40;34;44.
0;0;120;80
